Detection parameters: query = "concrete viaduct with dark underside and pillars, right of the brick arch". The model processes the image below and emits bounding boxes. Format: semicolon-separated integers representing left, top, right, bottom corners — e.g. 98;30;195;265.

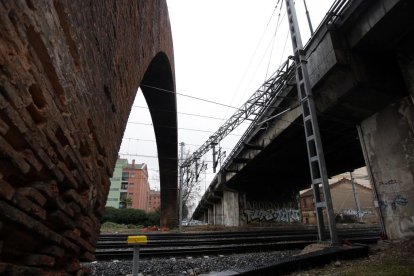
193;0;414;238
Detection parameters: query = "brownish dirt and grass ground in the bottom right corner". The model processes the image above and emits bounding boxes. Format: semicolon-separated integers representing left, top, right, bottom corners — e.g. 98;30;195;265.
289;237;414;276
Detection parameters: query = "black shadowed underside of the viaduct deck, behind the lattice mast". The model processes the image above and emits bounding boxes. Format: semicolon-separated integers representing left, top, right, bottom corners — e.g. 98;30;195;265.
226;117;364;200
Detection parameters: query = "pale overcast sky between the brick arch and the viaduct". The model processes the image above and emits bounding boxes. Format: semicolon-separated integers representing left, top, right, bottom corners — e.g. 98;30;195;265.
120;0;333;196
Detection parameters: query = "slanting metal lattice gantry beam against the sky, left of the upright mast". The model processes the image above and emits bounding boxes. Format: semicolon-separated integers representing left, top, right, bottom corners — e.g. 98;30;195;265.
181;60;291;167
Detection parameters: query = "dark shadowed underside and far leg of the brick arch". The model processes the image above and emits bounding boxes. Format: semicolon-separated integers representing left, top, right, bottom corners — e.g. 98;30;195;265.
141;52;178;229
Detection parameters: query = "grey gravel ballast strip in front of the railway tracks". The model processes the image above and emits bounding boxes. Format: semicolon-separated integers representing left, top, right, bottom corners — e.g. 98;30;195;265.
83;250;300;276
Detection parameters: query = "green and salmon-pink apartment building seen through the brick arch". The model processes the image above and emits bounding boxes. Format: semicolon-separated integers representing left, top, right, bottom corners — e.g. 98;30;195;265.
106;159;150;211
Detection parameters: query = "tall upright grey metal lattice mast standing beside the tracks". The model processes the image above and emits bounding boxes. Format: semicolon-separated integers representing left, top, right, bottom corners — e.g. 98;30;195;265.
285;0;338;244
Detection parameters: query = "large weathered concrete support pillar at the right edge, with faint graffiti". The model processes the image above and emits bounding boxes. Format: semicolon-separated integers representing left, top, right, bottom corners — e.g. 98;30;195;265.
361;97;414;239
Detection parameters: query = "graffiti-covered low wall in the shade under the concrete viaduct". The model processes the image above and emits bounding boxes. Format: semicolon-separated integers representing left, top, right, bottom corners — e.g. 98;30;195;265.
243;202;300;223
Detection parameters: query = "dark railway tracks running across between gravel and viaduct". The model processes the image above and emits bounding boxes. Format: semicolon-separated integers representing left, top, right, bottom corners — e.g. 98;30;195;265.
95;228;380;260
